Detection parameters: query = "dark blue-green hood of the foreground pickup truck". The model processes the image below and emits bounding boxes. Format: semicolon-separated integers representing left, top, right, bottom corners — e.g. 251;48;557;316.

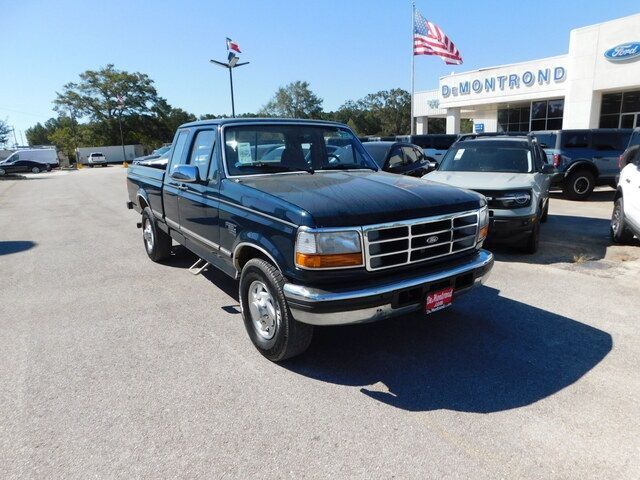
234;171;484;227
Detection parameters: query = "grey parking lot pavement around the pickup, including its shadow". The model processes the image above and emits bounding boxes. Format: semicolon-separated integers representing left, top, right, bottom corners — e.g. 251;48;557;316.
0;167;640;479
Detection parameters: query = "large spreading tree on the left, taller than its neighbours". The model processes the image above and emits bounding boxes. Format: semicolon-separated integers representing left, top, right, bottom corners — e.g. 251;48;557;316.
53;64;159;144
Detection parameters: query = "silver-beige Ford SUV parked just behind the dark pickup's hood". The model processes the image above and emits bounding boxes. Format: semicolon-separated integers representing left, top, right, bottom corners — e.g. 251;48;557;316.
424;135;555;253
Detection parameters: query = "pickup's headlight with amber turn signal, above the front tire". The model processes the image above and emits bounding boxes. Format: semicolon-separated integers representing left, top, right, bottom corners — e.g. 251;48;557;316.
296;230;364;269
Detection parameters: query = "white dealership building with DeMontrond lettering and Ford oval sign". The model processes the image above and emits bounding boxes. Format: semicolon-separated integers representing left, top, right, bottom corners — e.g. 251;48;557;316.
413;14;640;134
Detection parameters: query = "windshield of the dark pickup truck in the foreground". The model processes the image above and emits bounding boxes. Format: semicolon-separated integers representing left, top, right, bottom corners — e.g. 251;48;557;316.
224;124;377;175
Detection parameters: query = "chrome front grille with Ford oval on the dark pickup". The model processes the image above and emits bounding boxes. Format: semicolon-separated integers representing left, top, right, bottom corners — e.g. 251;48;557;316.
363;211;478;270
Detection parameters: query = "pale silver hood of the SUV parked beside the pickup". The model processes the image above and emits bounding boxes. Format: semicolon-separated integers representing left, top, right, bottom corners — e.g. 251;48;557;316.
422;170;535;190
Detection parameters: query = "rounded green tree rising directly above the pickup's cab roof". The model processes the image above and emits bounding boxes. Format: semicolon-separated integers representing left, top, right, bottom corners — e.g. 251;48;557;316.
259;80;322;118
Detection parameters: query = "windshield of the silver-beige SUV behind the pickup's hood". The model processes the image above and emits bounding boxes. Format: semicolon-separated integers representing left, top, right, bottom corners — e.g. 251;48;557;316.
439;140;533;173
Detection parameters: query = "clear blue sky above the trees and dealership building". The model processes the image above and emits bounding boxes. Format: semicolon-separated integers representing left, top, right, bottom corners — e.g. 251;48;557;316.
0;0;640;141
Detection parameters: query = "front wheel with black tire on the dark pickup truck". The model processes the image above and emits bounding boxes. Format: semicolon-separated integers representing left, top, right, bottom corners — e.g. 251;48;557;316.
239;258;313;362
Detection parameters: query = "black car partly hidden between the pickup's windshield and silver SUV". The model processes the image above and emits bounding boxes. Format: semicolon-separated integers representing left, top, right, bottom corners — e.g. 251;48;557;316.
362;142;435;177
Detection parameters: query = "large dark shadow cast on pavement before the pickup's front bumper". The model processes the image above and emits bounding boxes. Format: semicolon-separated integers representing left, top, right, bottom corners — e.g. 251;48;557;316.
283;287;612;413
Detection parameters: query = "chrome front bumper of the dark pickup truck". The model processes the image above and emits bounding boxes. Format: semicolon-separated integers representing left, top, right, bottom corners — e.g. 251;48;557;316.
284;250;493;325
